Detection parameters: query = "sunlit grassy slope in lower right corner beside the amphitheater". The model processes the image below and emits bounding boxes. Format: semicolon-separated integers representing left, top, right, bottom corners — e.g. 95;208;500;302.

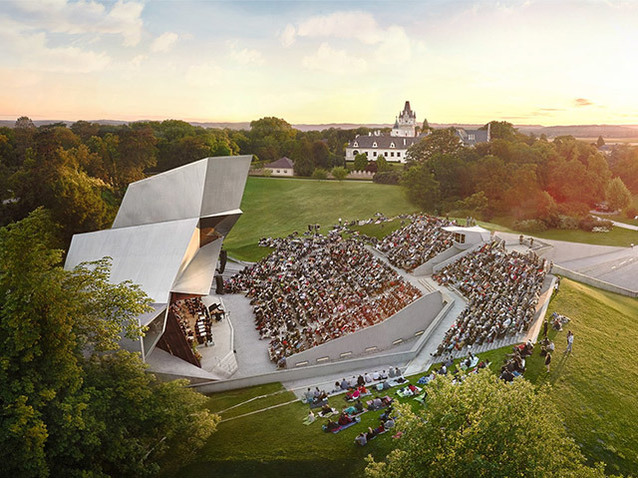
526;279;638;475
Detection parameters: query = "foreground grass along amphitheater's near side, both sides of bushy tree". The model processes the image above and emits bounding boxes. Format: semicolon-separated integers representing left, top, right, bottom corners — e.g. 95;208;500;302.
170;279;638;478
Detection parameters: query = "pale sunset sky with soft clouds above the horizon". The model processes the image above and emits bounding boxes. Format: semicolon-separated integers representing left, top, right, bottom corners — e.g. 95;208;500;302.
0;0;638;126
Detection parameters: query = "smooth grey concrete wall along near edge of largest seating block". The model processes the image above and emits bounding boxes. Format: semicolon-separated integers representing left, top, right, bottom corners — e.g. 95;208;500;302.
286;291;443;368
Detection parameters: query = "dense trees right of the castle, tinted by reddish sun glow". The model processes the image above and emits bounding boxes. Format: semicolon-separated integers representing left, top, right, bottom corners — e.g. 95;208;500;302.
401;122;638;229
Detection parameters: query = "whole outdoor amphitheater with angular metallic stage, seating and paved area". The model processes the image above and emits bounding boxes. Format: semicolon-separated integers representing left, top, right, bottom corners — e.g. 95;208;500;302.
66;156;638;396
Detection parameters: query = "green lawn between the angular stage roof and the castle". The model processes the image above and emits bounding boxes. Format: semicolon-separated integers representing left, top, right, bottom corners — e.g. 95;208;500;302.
224;177;416;261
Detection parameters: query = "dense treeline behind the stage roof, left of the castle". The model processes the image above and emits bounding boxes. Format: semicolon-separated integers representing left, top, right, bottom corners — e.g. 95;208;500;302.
0;117;368;241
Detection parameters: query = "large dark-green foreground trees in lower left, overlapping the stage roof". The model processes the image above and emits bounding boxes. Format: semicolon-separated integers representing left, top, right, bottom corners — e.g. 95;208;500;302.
0;209;217;477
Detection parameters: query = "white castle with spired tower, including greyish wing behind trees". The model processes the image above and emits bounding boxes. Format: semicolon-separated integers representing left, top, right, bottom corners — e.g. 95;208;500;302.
346;101;490;163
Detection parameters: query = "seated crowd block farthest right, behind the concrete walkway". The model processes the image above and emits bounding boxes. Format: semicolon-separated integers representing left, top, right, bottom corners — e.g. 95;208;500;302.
432;241;548;355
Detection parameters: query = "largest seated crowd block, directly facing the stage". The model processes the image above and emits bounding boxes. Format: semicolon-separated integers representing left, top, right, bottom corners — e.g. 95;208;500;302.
226;230;421;363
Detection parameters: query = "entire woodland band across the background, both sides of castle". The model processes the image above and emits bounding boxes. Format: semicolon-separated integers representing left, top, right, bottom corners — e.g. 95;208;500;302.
0;116;638;243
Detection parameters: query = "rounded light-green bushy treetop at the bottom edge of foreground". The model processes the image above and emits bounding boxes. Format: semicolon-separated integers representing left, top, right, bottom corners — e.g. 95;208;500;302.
366;370;616;478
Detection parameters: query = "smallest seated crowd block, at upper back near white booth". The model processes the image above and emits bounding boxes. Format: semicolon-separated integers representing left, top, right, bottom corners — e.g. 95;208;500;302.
377;215;453;272
